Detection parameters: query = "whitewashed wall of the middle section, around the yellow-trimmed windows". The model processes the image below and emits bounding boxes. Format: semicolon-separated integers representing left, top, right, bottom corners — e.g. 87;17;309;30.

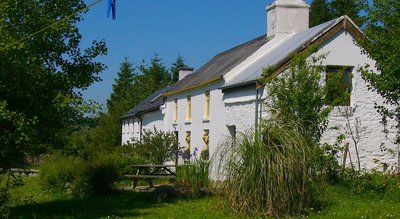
163;82;225;163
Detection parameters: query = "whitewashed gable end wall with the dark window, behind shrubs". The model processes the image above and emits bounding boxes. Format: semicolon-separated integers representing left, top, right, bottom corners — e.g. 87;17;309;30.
319;31;397;169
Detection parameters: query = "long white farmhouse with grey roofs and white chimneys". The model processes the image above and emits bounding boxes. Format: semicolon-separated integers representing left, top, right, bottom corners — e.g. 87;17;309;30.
122;0;396;171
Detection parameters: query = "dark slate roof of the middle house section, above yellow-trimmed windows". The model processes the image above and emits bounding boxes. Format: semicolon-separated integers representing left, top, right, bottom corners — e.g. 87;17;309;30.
167;35;267;92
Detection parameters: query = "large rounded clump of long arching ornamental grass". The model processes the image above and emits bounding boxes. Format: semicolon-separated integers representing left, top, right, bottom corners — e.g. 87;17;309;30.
220;121;321;216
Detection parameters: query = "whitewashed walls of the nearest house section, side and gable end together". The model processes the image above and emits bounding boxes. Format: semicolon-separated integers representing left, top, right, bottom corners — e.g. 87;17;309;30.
224;28;397;169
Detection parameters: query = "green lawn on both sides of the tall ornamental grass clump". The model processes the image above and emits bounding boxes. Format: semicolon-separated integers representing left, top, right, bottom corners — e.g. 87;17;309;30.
5;177;400;218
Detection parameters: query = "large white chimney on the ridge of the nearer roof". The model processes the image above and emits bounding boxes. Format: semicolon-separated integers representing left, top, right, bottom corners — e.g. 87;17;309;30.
266;0;310;37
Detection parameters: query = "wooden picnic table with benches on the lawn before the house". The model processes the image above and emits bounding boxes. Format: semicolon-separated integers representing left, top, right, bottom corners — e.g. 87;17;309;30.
124;164;176;189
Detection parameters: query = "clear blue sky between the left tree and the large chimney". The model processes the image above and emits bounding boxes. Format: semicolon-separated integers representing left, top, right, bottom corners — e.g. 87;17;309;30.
78;0;310;108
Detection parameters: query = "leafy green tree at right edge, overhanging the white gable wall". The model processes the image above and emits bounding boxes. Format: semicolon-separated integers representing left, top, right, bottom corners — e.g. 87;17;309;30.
358;0;400;171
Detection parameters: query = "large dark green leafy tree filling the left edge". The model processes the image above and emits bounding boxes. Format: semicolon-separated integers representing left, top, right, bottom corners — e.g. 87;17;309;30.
0;0;107;165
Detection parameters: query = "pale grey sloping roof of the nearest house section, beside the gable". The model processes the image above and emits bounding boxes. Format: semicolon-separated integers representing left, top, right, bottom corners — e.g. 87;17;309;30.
222;16;345;89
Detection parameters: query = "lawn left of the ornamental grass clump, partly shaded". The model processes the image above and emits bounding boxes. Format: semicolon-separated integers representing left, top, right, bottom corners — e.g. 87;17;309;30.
7;177;239;218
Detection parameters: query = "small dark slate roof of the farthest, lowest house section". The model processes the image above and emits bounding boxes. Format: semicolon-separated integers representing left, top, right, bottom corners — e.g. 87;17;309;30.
121;87;168;119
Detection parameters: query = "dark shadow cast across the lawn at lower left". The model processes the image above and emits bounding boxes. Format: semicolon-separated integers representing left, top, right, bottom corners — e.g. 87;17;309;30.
12;190;176;218
